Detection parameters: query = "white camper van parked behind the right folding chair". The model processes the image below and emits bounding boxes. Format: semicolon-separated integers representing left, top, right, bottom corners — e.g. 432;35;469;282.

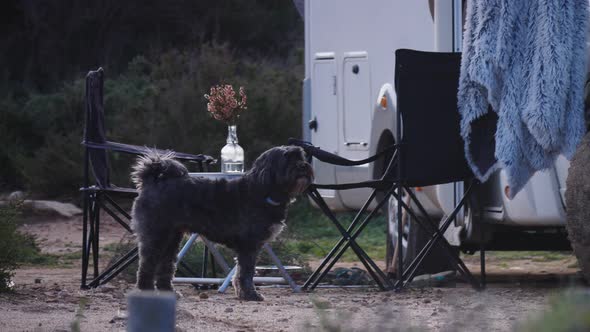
303;0;590;271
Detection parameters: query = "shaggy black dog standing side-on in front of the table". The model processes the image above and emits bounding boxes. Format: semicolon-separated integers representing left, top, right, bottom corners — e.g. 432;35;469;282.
132;146;313;301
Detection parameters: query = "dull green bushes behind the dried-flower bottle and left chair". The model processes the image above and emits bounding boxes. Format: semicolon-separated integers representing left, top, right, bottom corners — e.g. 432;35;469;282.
0;44;303;198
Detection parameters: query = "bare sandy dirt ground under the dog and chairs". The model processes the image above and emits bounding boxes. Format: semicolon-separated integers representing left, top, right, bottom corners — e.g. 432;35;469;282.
0;214;584;331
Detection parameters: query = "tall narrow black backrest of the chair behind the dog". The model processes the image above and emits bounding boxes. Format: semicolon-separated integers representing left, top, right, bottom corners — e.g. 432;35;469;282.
84;68;110;188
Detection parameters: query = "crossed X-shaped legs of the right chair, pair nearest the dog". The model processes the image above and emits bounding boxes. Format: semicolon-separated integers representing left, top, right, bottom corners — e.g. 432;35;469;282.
303;188;391;290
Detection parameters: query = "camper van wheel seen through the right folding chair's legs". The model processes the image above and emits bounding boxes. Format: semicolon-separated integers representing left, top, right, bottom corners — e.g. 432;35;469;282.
385;194;454;277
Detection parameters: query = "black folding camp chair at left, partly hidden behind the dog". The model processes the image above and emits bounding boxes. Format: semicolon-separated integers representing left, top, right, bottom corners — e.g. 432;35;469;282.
80;68;215;288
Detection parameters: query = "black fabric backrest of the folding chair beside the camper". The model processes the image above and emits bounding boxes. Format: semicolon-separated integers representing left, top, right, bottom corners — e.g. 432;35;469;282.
395;49;473;187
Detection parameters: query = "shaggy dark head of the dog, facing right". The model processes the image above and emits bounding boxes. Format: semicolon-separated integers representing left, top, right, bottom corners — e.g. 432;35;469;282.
250;146;313;197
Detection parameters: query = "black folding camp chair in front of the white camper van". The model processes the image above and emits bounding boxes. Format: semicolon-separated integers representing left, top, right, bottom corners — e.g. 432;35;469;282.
290;50;493;289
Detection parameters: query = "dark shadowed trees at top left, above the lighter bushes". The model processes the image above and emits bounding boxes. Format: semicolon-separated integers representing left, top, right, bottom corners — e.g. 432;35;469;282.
0;0;303;92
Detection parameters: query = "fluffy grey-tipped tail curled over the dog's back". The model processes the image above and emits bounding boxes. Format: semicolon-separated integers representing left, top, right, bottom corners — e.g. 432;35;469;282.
131;150;188;190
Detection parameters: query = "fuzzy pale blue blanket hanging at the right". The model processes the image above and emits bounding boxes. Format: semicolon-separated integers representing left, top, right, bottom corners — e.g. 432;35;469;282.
458;0;588;197
